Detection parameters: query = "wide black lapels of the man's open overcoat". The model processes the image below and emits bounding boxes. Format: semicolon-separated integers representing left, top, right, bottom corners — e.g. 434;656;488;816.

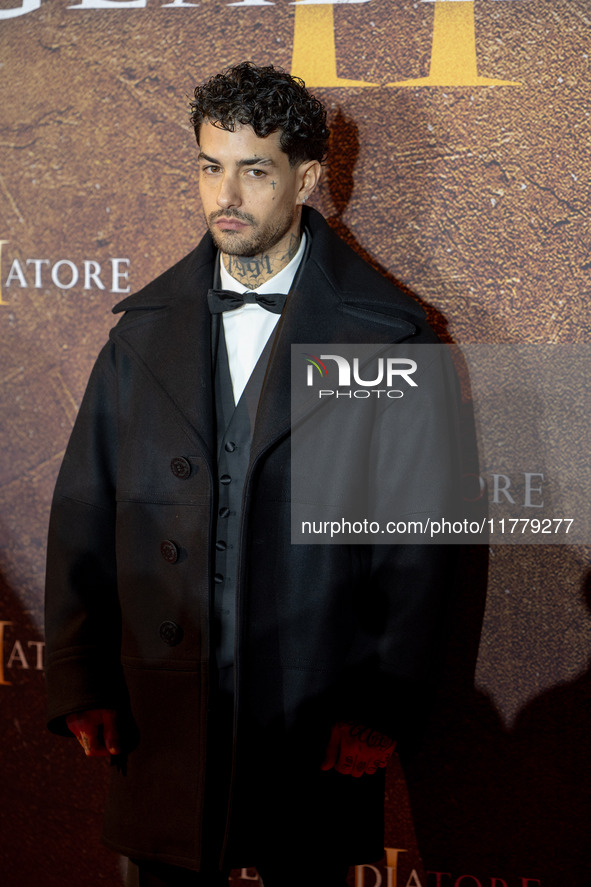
112;210;422;466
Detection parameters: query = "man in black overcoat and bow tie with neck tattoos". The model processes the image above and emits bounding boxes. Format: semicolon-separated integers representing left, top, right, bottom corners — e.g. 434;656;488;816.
47;63;458;887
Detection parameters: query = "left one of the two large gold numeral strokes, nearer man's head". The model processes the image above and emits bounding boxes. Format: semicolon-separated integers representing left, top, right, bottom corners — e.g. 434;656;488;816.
291;0;379;86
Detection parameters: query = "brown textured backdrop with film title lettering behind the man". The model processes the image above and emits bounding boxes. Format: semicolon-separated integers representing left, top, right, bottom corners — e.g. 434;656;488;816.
0;0;591;887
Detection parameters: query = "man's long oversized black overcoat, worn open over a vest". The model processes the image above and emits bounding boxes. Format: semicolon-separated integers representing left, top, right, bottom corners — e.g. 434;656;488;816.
47;210;460;869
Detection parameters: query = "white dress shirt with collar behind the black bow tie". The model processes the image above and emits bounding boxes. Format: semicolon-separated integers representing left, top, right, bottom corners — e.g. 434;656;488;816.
219;234;306;404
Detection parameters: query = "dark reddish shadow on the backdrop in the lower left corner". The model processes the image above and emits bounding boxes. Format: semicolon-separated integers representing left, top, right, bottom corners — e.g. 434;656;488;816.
0;573;121;887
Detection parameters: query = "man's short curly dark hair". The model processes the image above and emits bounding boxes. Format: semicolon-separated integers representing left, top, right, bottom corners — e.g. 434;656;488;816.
191;62;330;166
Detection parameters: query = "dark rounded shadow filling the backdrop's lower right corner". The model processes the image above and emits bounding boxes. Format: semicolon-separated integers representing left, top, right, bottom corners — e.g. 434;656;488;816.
407;560;591;887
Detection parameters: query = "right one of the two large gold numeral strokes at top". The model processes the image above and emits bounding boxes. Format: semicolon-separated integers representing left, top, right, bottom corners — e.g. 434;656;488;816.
388;0;521;86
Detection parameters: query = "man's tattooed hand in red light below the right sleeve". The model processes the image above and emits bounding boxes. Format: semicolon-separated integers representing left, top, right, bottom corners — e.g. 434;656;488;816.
322;721;396;776
